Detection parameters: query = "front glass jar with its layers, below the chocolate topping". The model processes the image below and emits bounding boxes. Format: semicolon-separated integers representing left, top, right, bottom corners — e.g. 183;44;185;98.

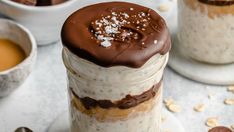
63;47;168;132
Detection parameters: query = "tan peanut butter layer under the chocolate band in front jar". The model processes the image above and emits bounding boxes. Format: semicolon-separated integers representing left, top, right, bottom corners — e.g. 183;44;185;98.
70;87;162;122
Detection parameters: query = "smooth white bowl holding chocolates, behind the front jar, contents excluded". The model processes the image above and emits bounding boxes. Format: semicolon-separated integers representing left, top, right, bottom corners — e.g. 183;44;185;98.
0;0;79;45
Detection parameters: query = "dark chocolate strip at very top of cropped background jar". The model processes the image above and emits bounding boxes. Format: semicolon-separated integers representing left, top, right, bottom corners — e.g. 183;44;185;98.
198;0;234;6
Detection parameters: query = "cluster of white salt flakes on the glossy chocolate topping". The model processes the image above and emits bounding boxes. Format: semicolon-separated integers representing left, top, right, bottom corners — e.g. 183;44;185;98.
91;8;151;47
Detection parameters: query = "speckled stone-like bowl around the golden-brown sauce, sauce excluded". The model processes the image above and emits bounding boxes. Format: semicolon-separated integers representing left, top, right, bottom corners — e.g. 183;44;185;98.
0;19;37;97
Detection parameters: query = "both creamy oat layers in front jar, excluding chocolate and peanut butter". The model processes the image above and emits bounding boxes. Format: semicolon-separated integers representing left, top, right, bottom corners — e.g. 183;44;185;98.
63;49;168;132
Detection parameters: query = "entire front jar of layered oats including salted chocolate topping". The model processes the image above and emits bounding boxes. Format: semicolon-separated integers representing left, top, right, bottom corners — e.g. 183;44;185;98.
62;2;171;132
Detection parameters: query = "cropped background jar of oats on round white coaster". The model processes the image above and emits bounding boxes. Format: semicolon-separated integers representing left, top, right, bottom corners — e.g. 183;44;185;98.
178;0;234;64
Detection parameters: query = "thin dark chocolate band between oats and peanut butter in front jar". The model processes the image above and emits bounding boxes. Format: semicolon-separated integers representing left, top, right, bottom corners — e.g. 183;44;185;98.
70;81;162;109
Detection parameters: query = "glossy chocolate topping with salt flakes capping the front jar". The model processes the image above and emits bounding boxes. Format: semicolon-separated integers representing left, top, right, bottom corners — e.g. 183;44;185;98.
61;2;171;68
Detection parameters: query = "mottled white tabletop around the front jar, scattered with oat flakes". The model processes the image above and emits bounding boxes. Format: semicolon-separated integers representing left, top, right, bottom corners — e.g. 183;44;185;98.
0;0;234;132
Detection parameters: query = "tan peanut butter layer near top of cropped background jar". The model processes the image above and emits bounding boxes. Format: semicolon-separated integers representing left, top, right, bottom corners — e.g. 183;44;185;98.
183;0;234;19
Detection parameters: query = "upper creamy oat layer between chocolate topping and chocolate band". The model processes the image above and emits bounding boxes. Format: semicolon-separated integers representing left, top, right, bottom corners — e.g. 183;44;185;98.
63;49;168;101
